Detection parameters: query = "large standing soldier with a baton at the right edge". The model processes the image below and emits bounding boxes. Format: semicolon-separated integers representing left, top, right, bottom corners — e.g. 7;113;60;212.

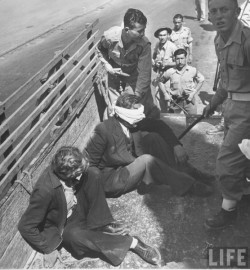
204;0;250;229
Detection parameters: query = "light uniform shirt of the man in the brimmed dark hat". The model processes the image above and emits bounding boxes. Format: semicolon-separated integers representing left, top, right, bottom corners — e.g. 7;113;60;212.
153;40;177;64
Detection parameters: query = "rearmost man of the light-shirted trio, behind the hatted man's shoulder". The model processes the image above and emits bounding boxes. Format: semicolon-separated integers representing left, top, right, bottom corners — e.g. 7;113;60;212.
171;14;193;64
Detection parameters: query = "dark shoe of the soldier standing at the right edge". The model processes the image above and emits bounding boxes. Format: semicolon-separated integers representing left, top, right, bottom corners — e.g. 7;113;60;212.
205;209;237;230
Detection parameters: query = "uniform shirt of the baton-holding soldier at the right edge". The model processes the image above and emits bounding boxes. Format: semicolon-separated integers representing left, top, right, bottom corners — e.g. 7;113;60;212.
215;21;250;101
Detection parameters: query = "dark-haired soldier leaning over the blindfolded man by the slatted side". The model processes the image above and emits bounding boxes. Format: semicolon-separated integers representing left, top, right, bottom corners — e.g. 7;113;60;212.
98;8;159;118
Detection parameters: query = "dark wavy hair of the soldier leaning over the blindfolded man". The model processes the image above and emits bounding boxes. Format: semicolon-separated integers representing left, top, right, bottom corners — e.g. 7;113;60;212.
124;8;147;29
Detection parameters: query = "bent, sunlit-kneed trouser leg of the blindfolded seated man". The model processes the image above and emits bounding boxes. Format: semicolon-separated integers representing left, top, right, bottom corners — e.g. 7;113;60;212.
102;154;195;196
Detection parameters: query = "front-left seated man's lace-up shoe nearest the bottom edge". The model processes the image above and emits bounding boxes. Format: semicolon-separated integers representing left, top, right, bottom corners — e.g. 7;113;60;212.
132;236;161;265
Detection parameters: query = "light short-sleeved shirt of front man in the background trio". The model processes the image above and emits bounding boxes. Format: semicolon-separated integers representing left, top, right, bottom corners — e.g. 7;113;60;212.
163;65;204;96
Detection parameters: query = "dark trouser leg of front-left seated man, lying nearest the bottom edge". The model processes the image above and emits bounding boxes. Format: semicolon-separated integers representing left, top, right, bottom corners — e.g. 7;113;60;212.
62;223;132;266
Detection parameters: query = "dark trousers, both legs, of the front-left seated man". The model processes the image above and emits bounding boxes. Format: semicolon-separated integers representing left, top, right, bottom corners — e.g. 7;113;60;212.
62;170;132;265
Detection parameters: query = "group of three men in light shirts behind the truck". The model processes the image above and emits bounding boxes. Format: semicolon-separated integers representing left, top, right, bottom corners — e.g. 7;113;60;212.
152;14;204;114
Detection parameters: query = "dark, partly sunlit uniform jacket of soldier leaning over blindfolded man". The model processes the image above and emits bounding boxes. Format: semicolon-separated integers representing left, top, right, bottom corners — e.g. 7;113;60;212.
98;26;152;95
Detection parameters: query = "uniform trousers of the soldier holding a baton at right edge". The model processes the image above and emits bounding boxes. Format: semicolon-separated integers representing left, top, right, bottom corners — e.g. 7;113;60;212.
216;99;250;201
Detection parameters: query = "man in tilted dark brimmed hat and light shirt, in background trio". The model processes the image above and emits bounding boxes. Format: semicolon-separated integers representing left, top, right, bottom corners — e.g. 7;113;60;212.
152;27;177;71
